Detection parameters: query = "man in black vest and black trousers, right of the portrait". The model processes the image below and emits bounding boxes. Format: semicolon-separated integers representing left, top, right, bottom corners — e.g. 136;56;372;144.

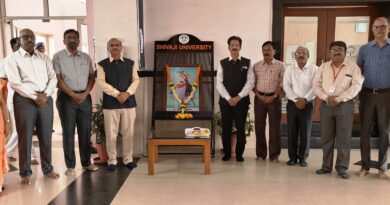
217;36;254;162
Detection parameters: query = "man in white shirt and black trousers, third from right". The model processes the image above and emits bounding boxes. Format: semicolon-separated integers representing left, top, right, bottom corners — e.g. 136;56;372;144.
283;46;318;167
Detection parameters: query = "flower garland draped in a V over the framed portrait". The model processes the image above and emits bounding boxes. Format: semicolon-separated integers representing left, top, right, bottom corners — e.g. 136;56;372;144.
165;66;200;119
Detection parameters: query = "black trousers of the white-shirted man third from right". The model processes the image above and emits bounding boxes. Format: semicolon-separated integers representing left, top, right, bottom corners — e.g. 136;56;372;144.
287;100;313;161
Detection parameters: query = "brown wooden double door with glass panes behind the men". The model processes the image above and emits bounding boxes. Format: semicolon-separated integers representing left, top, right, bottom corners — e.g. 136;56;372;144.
282;6;378;122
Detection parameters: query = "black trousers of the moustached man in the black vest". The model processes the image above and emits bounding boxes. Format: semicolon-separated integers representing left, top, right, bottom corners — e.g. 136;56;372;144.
219;99;249;157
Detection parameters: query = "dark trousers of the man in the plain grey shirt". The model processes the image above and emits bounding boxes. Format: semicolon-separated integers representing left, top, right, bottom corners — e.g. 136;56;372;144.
56;91;92;168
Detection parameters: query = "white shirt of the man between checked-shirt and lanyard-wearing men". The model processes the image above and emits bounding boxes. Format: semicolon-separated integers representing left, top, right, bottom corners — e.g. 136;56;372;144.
283;63;318;102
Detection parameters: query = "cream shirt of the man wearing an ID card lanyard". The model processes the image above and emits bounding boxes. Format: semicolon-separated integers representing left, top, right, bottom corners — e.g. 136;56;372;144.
313;60;364;102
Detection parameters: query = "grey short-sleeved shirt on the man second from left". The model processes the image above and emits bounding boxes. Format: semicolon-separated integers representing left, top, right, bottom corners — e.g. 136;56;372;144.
53;49;95;91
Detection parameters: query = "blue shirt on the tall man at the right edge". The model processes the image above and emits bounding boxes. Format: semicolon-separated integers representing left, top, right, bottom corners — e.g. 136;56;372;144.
357;38;390;89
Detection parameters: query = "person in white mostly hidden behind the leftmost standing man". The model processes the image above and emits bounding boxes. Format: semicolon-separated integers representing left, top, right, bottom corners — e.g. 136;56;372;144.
0;38;39;165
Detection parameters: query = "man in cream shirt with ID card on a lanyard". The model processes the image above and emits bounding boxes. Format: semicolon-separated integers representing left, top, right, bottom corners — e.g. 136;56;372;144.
313;41;364;179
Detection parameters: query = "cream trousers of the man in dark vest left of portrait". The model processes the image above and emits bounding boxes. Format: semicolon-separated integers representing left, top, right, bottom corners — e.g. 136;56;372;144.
103;108;136;165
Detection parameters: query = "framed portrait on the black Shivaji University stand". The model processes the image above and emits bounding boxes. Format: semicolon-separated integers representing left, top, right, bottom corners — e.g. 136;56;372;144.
164;65;201;112
